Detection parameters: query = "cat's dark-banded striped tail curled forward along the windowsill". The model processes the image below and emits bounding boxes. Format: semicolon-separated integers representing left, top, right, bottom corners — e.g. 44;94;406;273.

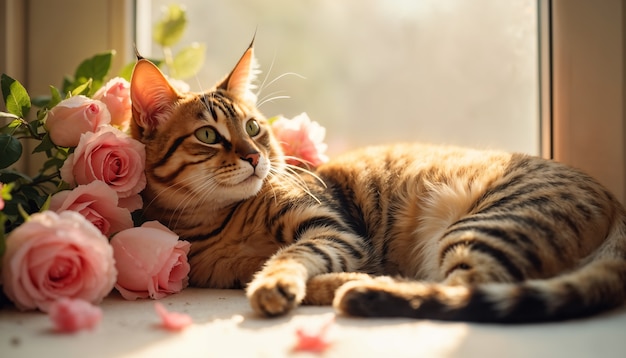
334;223;626;323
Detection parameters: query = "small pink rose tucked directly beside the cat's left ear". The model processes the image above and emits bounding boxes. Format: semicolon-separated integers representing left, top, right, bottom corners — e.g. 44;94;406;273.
93;77;132;131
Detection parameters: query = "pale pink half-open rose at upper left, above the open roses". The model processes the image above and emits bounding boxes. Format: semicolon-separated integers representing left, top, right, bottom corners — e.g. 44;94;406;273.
45;96;111;147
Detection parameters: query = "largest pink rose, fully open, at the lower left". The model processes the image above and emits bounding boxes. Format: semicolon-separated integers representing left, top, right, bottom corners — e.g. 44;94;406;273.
2;211;117;312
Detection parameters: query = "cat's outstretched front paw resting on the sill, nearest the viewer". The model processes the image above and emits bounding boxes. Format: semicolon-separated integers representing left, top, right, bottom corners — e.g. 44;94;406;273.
246;276;306;317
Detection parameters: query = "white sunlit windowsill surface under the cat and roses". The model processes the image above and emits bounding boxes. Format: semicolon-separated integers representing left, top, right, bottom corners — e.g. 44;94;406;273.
0;288;626;358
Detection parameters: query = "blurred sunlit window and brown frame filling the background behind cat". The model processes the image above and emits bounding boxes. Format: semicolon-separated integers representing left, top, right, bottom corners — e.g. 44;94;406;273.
0;0;626;202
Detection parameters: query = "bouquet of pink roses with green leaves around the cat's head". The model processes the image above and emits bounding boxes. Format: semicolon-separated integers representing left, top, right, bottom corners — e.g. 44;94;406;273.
0;7;327;328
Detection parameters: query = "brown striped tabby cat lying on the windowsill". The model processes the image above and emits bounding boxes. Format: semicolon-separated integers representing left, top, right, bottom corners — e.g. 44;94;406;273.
131;40;626;323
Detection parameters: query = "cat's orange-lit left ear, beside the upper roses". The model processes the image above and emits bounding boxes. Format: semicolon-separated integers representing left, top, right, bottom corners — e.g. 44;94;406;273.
130;59;179;139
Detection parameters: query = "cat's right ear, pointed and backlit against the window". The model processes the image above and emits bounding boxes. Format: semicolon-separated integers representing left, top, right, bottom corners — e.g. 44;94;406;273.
217;39;259;104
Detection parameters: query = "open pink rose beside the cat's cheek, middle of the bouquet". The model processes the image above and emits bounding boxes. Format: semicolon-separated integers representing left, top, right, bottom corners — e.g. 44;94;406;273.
61;126;146;212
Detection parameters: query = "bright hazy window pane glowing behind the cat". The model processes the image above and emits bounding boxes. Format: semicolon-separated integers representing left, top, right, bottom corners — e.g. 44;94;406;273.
138;0;540;154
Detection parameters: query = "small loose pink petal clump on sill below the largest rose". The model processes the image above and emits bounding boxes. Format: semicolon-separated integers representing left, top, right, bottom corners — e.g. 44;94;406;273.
48;297;102;333
